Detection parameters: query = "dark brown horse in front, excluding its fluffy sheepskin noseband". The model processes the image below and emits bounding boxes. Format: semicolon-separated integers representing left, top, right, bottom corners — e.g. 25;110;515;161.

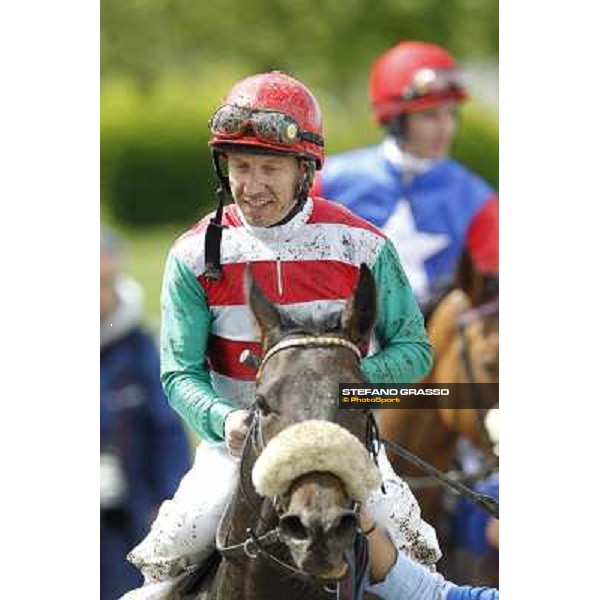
173;265;376;600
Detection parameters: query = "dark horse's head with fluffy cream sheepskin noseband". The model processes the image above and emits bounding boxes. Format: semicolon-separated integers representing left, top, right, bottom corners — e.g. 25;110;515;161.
248;265;379;579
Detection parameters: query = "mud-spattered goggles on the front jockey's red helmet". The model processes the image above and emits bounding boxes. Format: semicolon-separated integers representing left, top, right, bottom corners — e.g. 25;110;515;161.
209;104;324;146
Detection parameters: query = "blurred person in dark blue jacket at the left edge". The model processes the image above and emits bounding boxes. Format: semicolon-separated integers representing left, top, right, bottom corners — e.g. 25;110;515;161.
100;231;189;600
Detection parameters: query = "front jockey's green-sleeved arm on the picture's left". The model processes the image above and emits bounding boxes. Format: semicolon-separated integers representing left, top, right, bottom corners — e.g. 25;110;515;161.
160;252;236;441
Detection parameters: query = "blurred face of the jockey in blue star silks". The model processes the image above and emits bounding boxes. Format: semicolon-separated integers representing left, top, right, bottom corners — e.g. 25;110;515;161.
404;101;458;158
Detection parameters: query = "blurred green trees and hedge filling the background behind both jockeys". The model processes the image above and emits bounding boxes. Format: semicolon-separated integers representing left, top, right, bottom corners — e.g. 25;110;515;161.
101;0;498;226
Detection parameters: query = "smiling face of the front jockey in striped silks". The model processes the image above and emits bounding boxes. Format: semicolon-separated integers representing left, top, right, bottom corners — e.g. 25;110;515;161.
227;152;302;227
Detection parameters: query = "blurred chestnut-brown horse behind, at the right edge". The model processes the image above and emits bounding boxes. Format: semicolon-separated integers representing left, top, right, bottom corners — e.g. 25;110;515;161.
378;254;499;576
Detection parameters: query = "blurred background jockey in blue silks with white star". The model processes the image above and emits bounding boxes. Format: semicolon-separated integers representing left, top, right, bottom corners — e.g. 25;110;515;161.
313;42;498;310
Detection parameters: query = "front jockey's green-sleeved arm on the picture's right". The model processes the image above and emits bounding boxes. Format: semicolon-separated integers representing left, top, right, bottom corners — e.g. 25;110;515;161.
361;240;433;383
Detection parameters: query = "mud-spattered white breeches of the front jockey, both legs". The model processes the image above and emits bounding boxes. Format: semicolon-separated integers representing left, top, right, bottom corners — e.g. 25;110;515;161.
128;443;441;582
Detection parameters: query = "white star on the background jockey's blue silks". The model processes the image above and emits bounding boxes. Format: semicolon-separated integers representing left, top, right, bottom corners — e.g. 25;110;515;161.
382;200;450;302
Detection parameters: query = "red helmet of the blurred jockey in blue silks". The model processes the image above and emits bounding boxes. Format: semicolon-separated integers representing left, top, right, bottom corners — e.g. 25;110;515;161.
369;42;468;125
